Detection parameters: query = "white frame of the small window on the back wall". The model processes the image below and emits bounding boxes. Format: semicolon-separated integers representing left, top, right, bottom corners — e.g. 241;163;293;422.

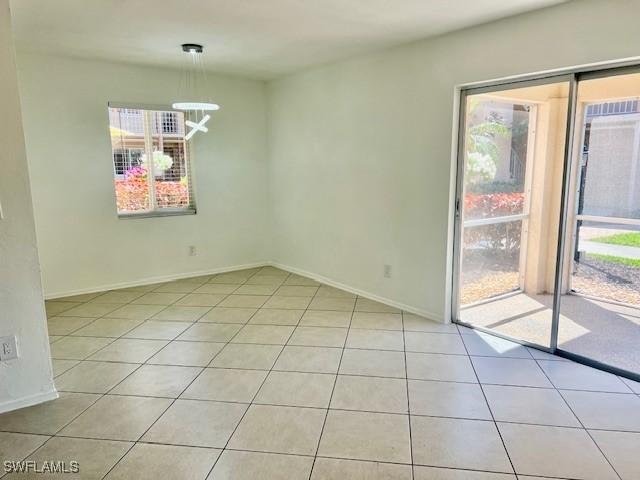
107;102;197;219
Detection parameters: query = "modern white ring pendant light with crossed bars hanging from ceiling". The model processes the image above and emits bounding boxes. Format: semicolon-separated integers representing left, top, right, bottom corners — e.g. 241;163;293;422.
172;43;220;140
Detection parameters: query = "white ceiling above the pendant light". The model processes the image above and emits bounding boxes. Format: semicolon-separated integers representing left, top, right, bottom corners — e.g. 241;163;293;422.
11;0;564;79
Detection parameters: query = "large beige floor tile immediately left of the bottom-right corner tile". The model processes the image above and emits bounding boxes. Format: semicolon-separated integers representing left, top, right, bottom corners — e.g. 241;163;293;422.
498;423;617;480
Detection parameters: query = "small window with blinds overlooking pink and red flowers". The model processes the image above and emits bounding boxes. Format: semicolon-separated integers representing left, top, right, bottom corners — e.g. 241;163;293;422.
109;105;195;217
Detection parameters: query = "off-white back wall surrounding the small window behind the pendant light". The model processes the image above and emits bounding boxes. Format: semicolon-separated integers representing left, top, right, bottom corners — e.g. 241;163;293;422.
18;53;268;297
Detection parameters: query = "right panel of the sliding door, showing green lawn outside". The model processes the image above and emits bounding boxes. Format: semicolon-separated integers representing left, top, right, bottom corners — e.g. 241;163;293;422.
558;70;640;373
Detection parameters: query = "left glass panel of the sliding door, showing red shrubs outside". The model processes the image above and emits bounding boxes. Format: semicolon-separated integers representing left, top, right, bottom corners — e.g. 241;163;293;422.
457;79;569;348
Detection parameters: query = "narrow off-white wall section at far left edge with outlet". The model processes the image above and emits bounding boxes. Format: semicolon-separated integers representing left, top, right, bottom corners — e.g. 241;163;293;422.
0;0;57;413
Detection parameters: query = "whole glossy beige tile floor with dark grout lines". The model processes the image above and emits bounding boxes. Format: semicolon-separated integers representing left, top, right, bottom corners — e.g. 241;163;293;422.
0;267;640;480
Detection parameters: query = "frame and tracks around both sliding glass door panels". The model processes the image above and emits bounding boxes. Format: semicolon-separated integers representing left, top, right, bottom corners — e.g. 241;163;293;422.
451;59;640;381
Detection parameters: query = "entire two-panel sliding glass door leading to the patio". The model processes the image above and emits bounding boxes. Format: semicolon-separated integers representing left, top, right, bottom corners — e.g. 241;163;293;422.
452;65;640;378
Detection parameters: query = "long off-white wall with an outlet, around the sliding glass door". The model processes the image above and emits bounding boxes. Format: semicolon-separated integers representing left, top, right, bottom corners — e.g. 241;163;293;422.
269;0;640;320
